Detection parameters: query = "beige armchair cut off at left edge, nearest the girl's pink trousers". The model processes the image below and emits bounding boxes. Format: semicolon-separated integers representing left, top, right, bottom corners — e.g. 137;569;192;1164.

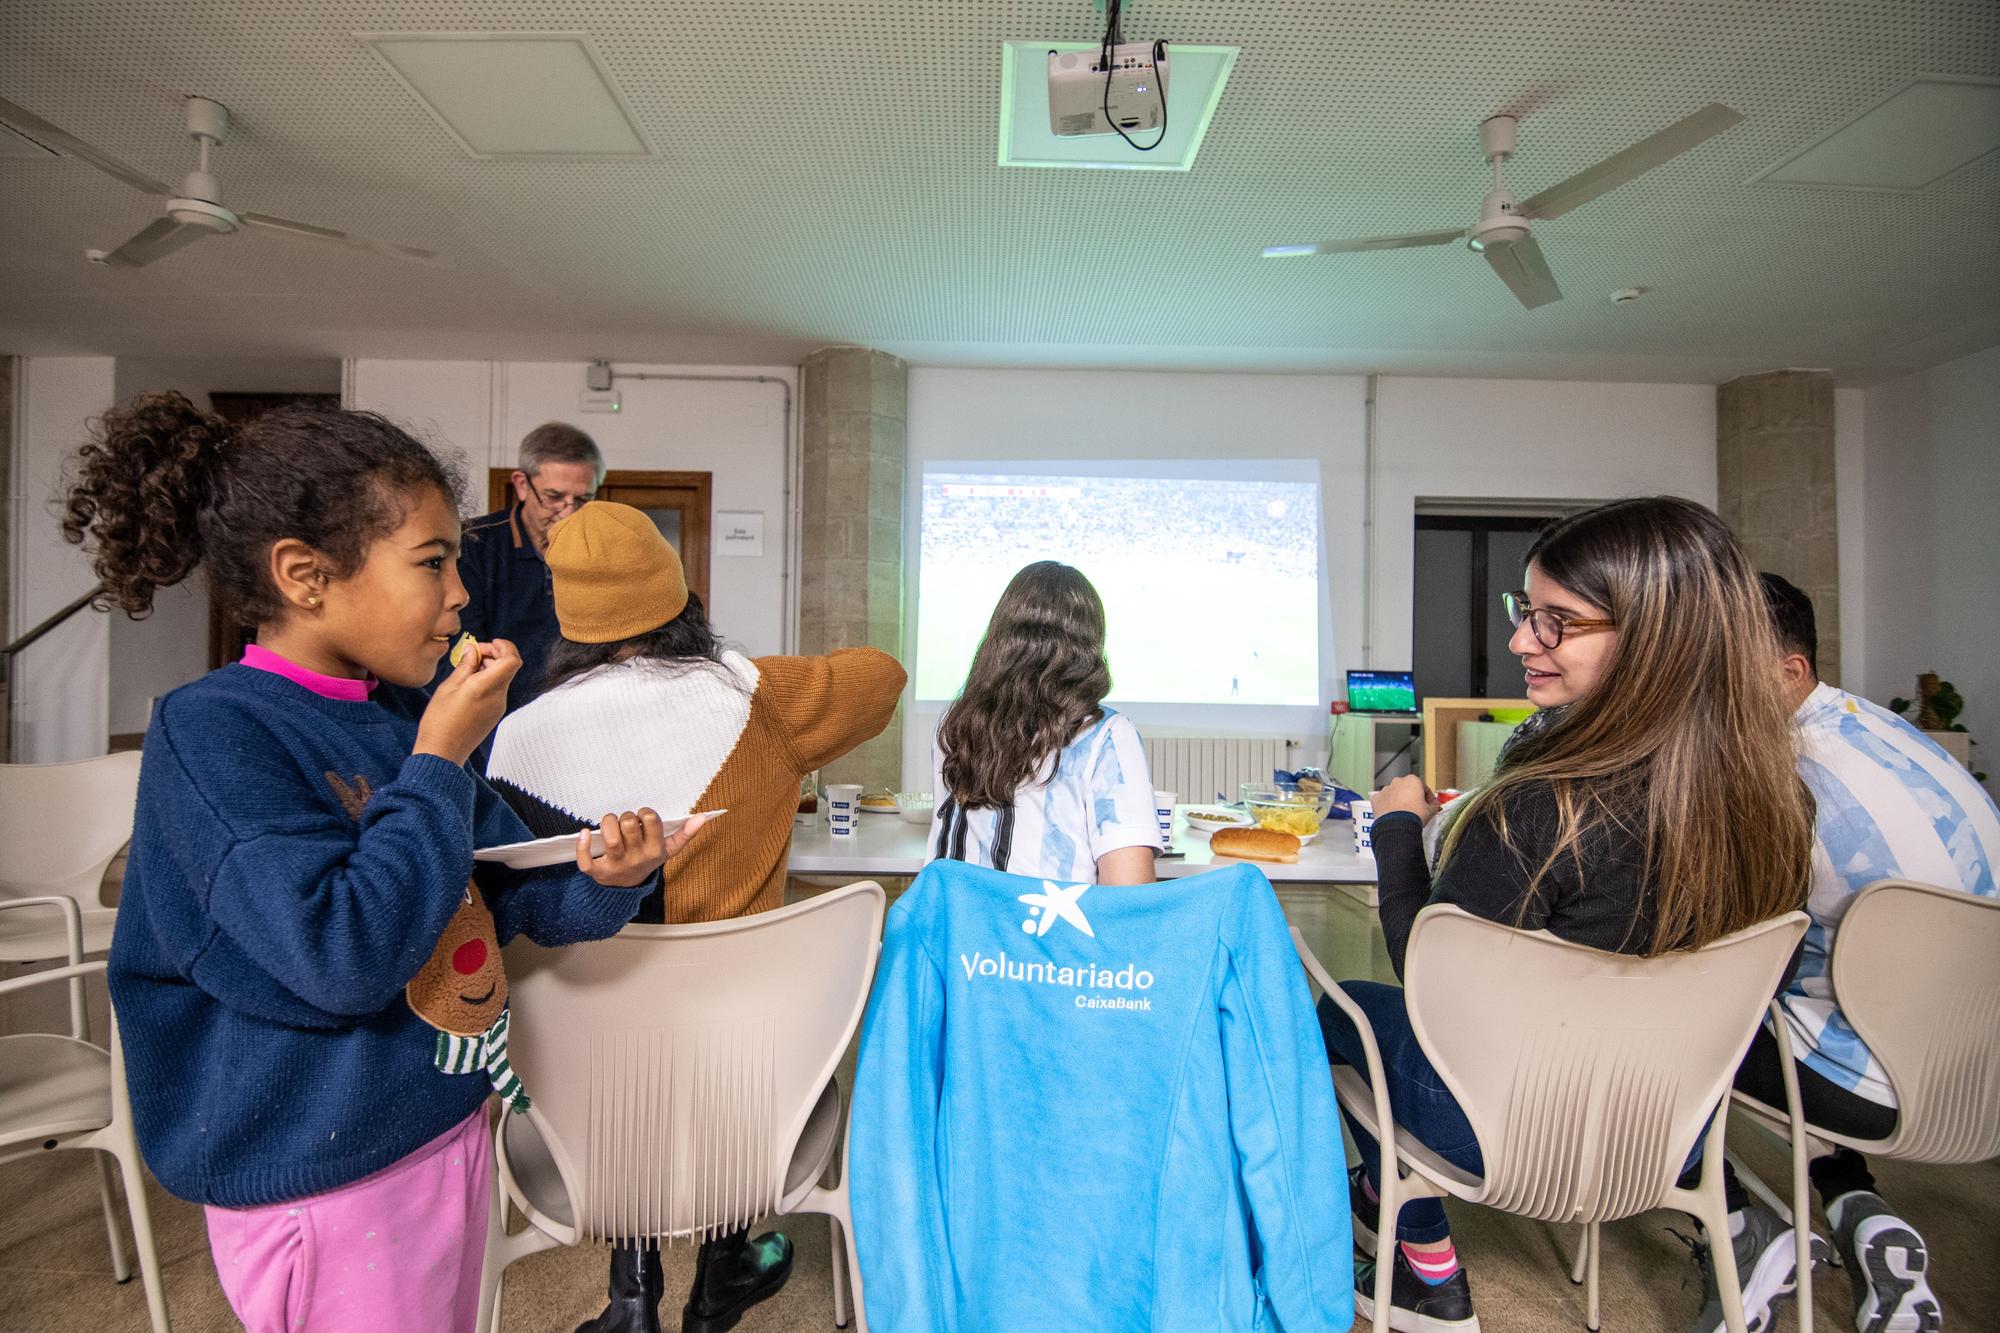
0;897;172;1333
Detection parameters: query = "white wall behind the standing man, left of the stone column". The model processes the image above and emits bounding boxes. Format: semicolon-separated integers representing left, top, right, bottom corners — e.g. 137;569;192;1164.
346;360;798;654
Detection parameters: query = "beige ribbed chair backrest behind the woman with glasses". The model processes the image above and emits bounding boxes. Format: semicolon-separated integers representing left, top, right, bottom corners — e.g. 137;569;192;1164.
1404;905;1806;1223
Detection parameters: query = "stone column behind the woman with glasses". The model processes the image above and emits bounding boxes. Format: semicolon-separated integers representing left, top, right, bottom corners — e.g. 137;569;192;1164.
1716;370;1840;685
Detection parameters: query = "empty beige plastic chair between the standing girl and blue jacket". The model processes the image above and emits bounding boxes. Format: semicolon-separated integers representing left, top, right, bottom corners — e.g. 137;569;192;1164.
480;883;886;1333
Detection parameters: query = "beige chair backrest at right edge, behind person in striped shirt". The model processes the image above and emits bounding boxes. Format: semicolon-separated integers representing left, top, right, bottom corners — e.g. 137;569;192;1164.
1832;879;2000;1163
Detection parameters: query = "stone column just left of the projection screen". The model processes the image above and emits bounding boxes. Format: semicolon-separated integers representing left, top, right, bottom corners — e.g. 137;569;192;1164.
798;346;910;789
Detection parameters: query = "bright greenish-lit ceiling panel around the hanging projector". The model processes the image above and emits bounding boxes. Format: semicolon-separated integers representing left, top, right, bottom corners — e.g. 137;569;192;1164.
1000;42;1240;172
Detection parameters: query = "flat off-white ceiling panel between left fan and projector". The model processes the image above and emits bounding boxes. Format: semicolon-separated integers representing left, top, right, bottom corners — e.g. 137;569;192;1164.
354;32;652;158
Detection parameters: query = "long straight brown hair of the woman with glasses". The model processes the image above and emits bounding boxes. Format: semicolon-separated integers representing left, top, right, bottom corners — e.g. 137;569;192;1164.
1444;496;1812;955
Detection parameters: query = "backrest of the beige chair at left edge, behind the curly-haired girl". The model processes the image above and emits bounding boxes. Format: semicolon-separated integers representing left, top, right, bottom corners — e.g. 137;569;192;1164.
0;751;140;907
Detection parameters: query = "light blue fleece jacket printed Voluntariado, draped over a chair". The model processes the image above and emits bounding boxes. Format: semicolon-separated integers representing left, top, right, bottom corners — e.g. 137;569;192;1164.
850;861;1354;1333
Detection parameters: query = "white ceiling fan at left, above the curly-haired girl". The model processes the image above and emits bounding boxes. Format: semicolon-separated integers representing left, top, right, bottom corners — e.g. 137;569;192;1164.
0;98;450;268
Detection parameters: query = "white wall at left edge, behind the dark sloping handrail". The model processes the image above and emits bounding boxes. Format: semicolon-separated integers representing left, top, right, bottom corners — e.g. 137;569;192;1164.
6;356;114;763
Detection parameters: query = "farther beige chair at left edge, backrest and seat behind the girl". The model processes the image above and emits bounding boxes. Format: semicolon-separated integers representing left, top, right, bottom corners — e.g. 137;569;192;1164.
0;751;140;992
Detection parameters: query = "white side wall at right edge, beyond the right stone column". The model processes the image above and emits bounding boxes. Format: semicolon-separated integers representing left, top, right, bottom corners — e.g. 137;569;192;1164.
1840;346;2000;789
